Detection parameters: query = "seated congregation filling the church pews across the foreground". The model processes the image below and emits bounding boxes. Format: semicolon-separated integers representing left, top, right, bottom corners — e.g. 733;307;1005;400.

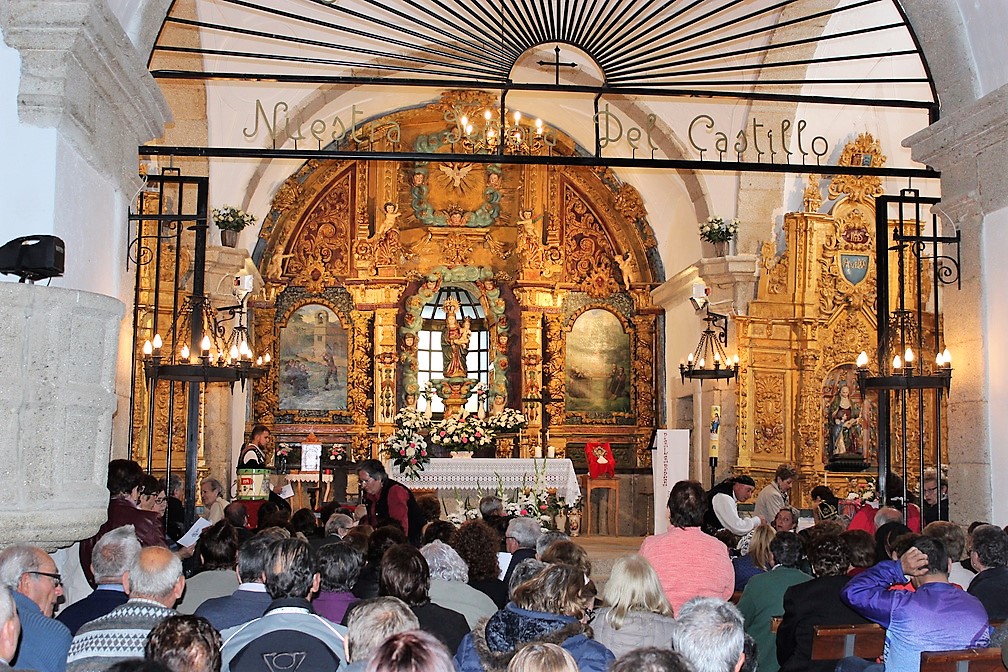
0;460;1008;672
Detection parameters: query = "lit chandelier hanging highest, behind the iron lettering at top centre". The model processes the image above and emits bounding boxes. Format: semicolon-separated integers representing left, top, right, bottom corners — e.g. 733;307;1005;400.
452;109;556;156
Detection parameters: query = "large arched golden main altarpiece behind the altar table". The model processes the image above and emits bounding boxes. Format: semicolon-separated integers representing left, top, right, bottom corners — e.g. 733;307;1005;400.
232;92;663;466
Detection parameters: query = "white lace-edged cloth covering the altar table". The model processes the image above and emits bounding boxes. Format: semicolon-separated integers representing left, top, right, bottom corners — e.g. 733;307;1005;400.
385;457;581;503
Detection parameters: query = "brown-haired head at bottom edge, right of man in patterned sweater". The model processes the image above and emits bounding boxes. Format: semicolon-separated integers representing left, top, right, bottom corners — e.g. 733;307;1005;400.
143;615;221;672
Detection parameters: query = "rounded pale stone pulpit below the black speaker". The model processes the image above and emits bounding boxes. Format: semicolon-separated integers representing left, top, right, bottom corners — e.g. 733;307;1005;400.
0;283;124;550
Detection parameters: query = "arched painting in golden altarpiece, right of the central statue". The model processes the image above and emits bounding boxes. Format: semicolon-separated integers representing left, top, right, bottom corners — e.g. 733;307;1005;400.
564;308;631;414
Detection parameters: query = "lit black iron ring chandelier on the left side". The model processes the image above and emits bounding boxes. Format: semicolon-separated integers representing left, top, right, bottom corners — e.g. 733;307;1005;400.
143;292;271;389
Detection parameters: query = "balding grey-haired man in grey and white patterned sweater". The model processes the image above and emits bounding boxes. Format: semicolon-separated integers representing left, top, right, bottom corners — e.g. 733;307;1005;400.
67;547;185;672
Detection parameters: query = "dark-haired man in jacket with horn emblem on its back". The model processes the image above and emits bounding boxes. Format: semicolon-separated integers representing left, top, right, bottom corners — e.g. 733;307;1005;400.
221;538;347;672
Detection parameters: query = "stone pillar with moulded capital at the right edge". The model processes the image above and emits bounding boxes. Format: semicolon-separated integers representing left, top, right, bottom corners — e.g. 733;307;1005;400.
904;86;1008;522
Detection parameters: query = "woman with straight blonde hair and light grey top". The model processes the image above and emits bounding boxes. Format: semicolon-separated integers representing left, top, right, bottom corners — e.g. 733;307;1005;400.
592;554;675;658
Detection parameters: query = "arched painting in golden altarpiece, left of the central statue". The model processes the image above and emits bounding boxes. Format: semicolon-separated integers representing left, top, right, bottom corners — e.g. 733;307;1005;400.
279;303;347;411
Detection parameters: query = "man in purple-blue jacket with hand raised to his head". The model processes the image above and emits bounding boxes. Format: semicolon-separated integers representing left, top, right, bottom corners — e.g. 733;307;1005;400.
837;537;990;672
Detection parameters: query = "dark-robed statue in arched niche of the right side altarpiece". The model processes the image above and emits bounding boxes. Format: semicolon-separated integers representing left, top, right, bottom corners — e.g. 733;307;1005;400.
823;364;878;464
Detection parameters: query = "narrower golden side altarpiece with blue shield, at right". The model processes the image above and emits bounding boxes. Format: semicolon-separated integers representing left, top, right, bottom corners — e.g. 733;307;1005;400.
736;134;943;506
